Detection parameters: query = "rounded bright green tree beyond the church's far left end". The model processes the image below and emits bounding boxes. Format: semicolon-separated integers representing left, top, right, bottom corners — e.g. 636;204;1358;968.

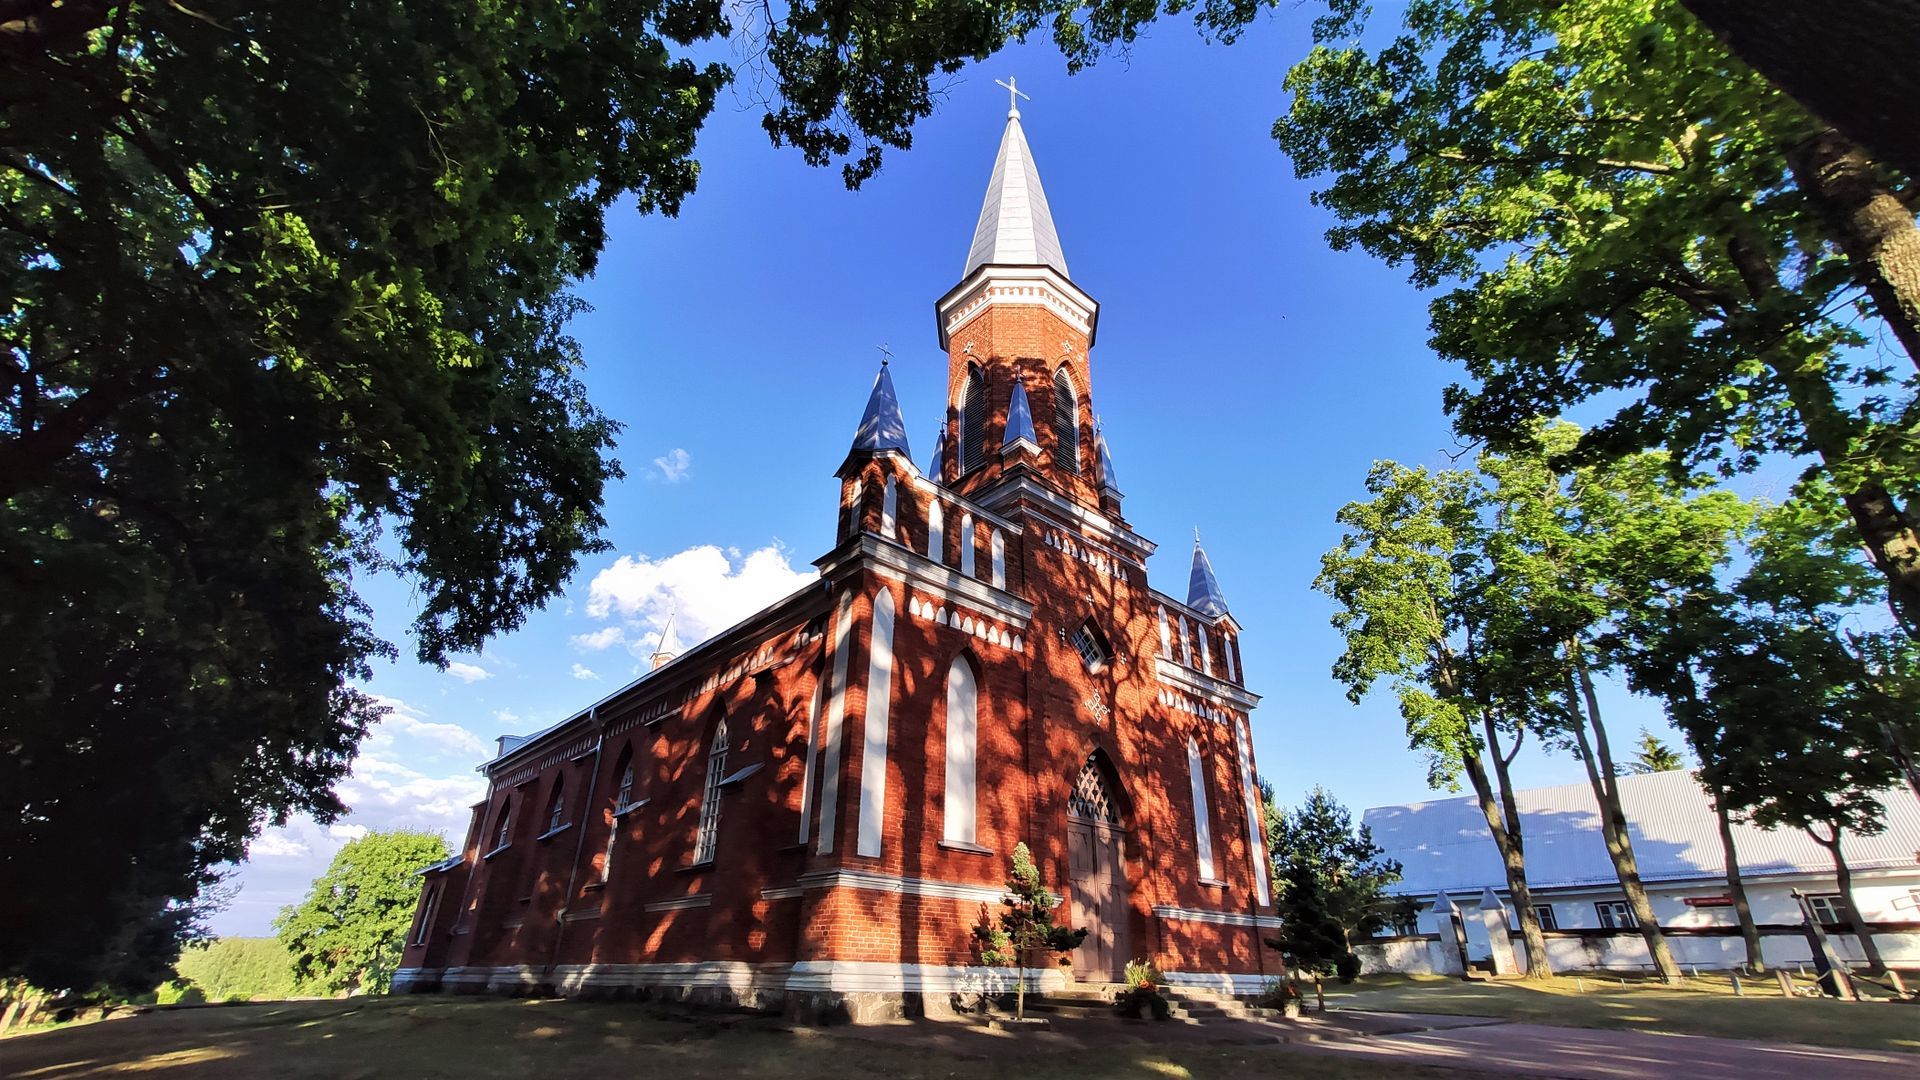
273;830;447;994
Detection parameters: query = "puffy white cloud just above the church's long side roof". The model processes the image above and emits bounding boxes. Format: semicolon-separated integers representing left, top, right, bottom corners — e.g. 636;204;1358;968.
576;542;816;655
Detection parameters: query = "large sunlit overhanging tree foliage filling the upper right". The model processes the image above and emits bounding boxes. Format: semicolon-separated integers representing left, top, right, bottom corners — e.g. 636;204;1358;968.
1275;0;1920;634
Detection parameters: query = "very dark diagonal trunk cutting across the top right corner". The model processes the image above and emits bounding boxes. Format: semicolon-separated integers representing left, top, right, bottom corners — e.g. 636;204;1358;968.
1680;0;1920;179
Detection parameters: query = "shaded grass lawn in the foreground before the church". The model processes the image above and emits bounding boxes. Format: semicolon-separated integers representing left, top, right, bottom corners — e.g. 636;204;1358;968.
0;995;1497;1080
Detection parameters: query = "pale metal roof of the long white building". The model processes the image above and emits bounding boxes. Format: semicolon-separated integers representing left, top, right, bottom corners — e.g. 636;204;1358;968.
1361;771;1920;894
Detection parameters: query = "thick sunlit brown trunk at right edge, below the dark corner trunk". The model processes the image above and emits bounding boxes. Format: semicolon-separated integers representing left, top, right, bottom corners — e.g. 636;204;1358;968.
1788;125;1920;367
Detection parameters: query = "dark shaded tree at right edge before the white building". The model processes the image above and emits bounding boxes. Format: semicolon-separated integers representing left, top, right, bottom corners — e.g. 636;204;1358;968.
1630;482;1920;969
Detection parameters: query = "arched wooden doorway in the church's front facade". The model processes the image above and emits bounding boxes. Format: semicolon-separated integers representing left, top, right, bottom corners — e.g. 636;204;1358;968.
1068;751;1127;982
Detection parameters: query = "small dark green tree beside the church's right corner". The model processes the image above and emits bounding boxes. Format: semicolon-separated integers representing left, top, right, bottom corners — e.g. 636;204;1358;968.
1263;788;1402;974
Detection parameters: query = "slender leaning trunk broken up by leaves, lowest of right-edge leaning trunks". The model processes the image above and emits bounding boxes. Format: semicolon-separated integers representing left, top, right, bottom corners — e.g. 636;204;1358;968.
1726;225;1920;640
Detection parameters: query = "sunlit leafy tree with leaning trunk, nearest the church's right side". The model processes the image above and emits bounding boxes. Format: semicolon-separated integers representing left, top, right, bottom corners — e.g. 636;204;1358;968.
1313;461;1553;978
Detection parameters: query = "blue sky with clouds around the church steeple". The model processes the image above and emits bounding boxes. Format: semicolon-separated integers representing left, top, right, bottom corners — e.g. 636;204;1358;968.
228;21;1697;934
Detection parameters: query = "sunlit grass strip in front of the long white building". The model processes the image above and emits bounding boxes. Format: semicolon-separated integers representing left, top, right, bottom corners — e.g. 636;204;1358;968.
1327;974;1920;1053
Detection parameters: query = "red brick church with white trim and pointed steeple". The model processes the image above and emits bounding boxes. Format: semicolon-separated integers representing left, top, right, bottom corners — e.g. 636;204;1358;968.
396;96;1279;1017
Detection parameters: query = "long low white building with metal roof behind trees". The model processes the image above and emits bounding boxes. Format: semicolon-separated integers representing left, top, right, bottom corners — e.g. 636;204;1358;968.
1361;771;1920;970
